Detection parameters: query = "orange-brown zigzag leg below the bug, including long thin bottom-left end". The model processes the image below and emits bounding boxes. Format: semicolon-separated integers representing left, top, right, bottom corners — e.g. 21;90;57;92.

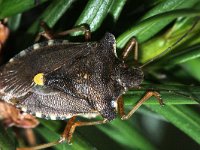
17;117;108;150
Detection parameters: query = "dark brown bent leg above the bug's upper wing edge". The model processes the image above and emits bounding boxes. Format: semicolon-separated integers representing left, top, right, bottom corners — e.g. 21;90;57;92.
35;21;91;41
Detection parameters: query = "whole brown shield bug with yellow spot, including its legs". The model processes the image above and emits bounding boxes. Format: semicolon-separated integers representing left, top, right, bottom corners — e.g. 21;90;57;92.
0;19;198;149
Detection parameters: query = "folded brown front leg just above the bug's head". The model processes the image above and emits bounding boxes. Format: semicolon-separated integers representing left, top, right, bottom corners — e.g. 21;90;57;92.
122;38;138;63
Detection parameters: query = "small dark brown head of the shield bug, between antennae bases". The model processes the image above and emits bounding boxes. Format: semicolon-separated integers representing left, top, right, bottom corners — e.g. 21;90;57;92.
117;67;144;89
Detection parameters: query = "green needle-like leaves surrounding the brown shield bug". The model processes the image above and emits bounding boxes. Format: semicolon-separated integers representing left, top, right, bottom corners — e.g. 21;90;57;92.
0;0;200;150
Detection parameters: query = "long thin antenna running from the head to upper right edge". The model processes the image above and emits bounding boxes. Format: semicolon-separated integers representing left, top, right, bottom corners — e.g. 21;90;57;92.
139;19;199;68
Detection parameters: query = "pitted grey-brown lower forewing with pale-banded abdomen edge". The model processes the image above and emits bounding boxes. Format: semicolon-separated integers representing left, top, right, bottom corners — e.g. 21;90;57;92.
17;88;96;120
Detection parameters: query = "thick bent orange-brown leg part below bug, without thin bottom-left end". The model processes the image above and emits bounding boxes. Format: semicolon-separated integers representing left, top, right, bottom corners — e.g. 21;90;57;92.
62;117;108;143
